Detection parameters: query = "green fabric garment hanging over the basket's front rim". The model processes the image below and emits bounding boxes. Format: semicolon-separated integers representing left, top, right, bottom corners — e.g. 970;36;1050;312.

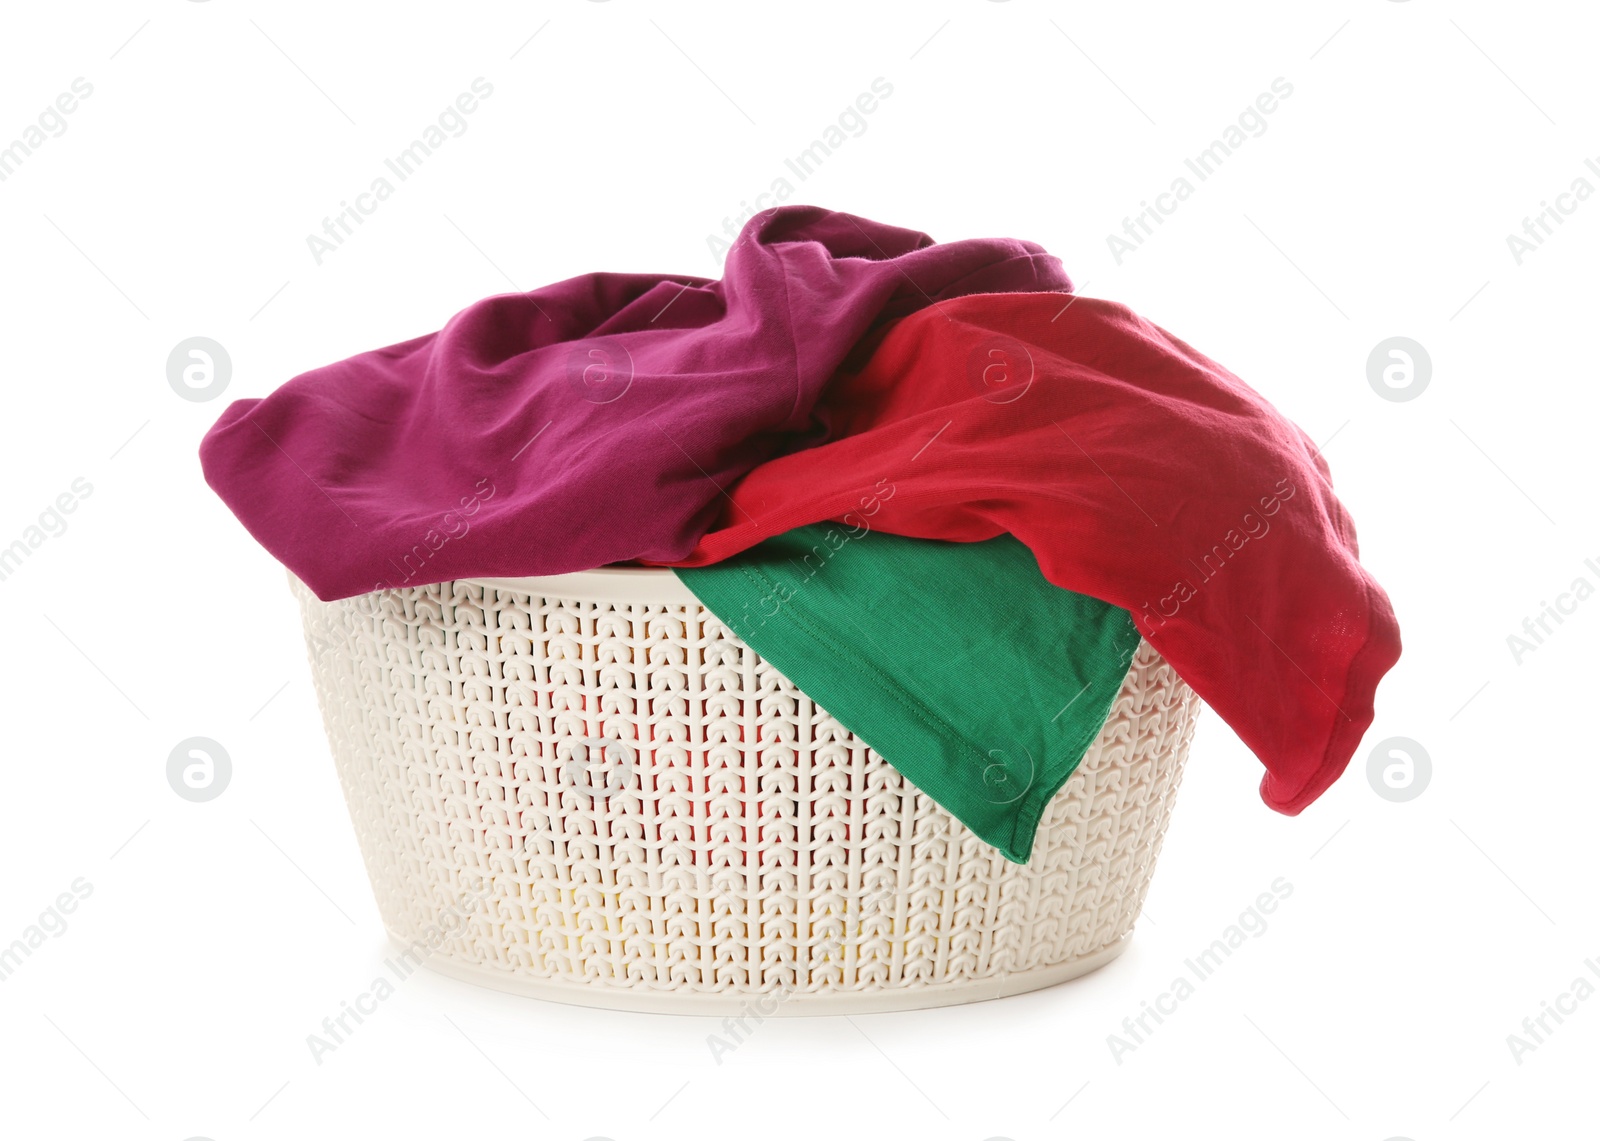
677;523;1139;864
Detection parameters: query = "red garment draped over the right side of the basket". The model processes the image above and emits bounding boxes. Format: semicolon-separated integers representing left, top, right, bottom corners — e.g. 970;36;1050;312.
662;293;1400;815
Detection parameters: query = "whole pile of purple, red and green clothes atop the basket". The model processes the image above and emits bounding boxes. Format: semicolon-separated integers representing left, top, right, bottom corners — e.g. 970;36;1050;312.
200;206;1400;863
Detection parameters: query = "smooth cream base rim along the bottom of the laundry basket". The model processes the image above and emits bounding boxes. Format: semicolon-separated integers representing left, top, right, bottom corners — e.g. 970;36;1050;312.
389;931;1133;1018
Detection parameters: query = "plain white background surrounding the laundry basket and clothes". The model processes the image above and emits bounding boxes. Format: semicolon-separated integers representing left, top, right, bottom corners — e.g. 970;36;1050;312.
0;0;1600;1141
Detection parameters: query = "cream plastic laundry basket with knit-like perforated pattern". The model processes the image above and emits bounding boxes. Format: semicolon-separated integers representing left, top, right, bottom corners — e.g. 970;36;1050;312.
291;568;1198;1016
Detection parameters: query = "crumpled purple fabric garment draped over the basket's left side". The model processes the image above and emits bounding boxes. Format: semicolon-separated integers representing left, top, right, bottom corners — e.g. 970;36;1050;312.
200;206;1072;600
